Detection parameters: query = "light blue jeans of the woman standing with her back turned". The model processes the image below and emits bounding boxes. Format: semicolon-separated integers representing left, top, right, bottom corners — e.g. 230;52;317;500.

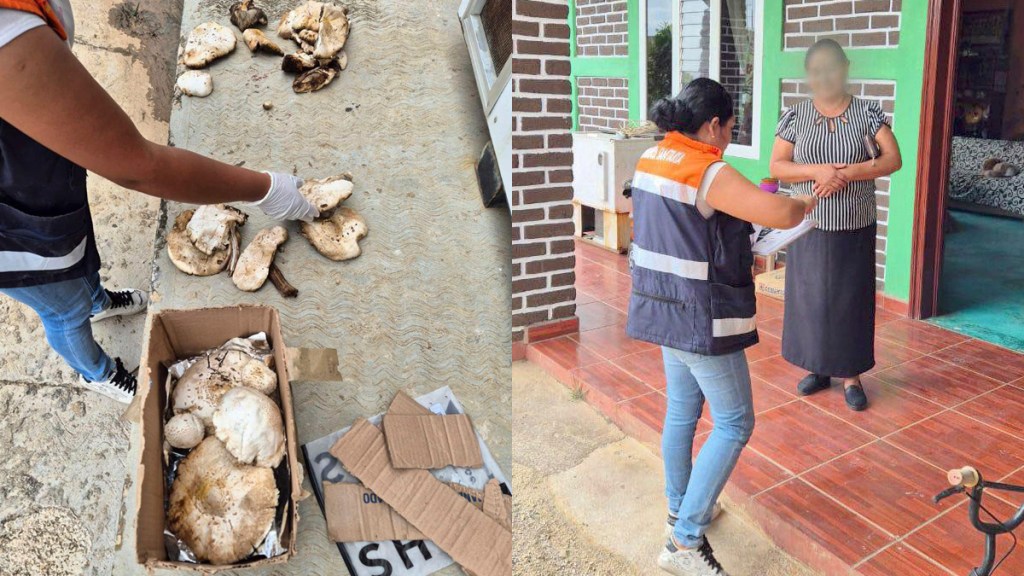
662;346;754;547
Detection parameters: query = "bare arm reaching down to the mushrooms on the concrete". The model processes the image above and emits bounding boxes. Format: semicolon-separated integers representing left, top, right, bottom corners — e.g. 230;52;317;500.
0;27;315;217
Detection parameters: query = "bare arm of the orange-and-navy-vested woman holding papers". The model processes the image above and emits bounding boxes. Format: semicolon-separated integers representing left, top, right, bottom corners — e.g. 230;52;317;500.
707;166;817;229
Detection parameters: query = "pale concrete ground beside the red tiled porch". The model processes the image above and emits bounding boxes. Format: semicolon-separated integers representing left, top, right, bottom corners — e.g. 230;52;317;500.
512;362;814;576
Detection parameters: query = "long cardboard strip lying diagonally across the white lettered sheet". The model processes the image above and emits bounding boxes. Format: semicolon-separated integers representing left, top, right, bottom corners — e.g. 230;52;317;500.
330;416;512;576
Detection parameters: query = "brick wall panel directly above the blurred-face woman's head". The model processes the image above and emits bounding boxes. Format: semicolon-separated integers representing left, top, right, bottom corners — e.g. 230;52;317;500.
784;0;903;49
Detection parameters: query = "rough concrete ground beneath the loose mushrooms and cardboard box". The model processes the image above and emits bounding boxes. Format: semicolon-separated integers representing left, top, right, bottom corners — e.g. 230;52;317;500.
0;0;512;576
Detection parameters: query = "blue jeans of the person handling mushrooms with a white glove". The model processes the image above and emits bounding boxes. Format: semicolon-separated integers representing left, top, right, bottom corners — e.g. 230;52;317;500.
0;273;115;382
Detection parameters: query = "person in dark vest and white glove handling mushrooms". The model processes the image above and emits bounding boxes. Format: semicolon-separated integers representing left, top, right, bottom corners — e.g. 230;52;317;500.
0;0;317;403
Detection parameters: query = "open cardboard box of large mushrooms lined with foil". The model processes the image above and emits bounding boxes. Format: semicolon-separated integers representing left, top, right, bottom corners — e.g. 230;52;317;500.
138;315;300;570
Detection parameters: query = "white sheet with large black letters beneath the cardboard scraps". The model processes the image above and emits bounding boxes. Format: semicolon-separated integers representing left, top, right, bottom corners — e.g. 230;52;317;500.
302;386;511;576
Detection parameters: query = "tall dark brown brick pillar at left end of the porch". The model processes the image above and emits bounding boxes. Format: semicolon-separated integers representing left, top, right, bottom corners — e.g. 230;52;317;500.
511;0;575;341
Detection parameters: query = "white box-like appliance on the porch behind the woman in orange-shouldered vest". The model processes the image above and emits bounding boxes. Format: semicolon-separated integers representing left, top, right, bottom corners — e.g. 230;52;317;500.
572;132;655;213
